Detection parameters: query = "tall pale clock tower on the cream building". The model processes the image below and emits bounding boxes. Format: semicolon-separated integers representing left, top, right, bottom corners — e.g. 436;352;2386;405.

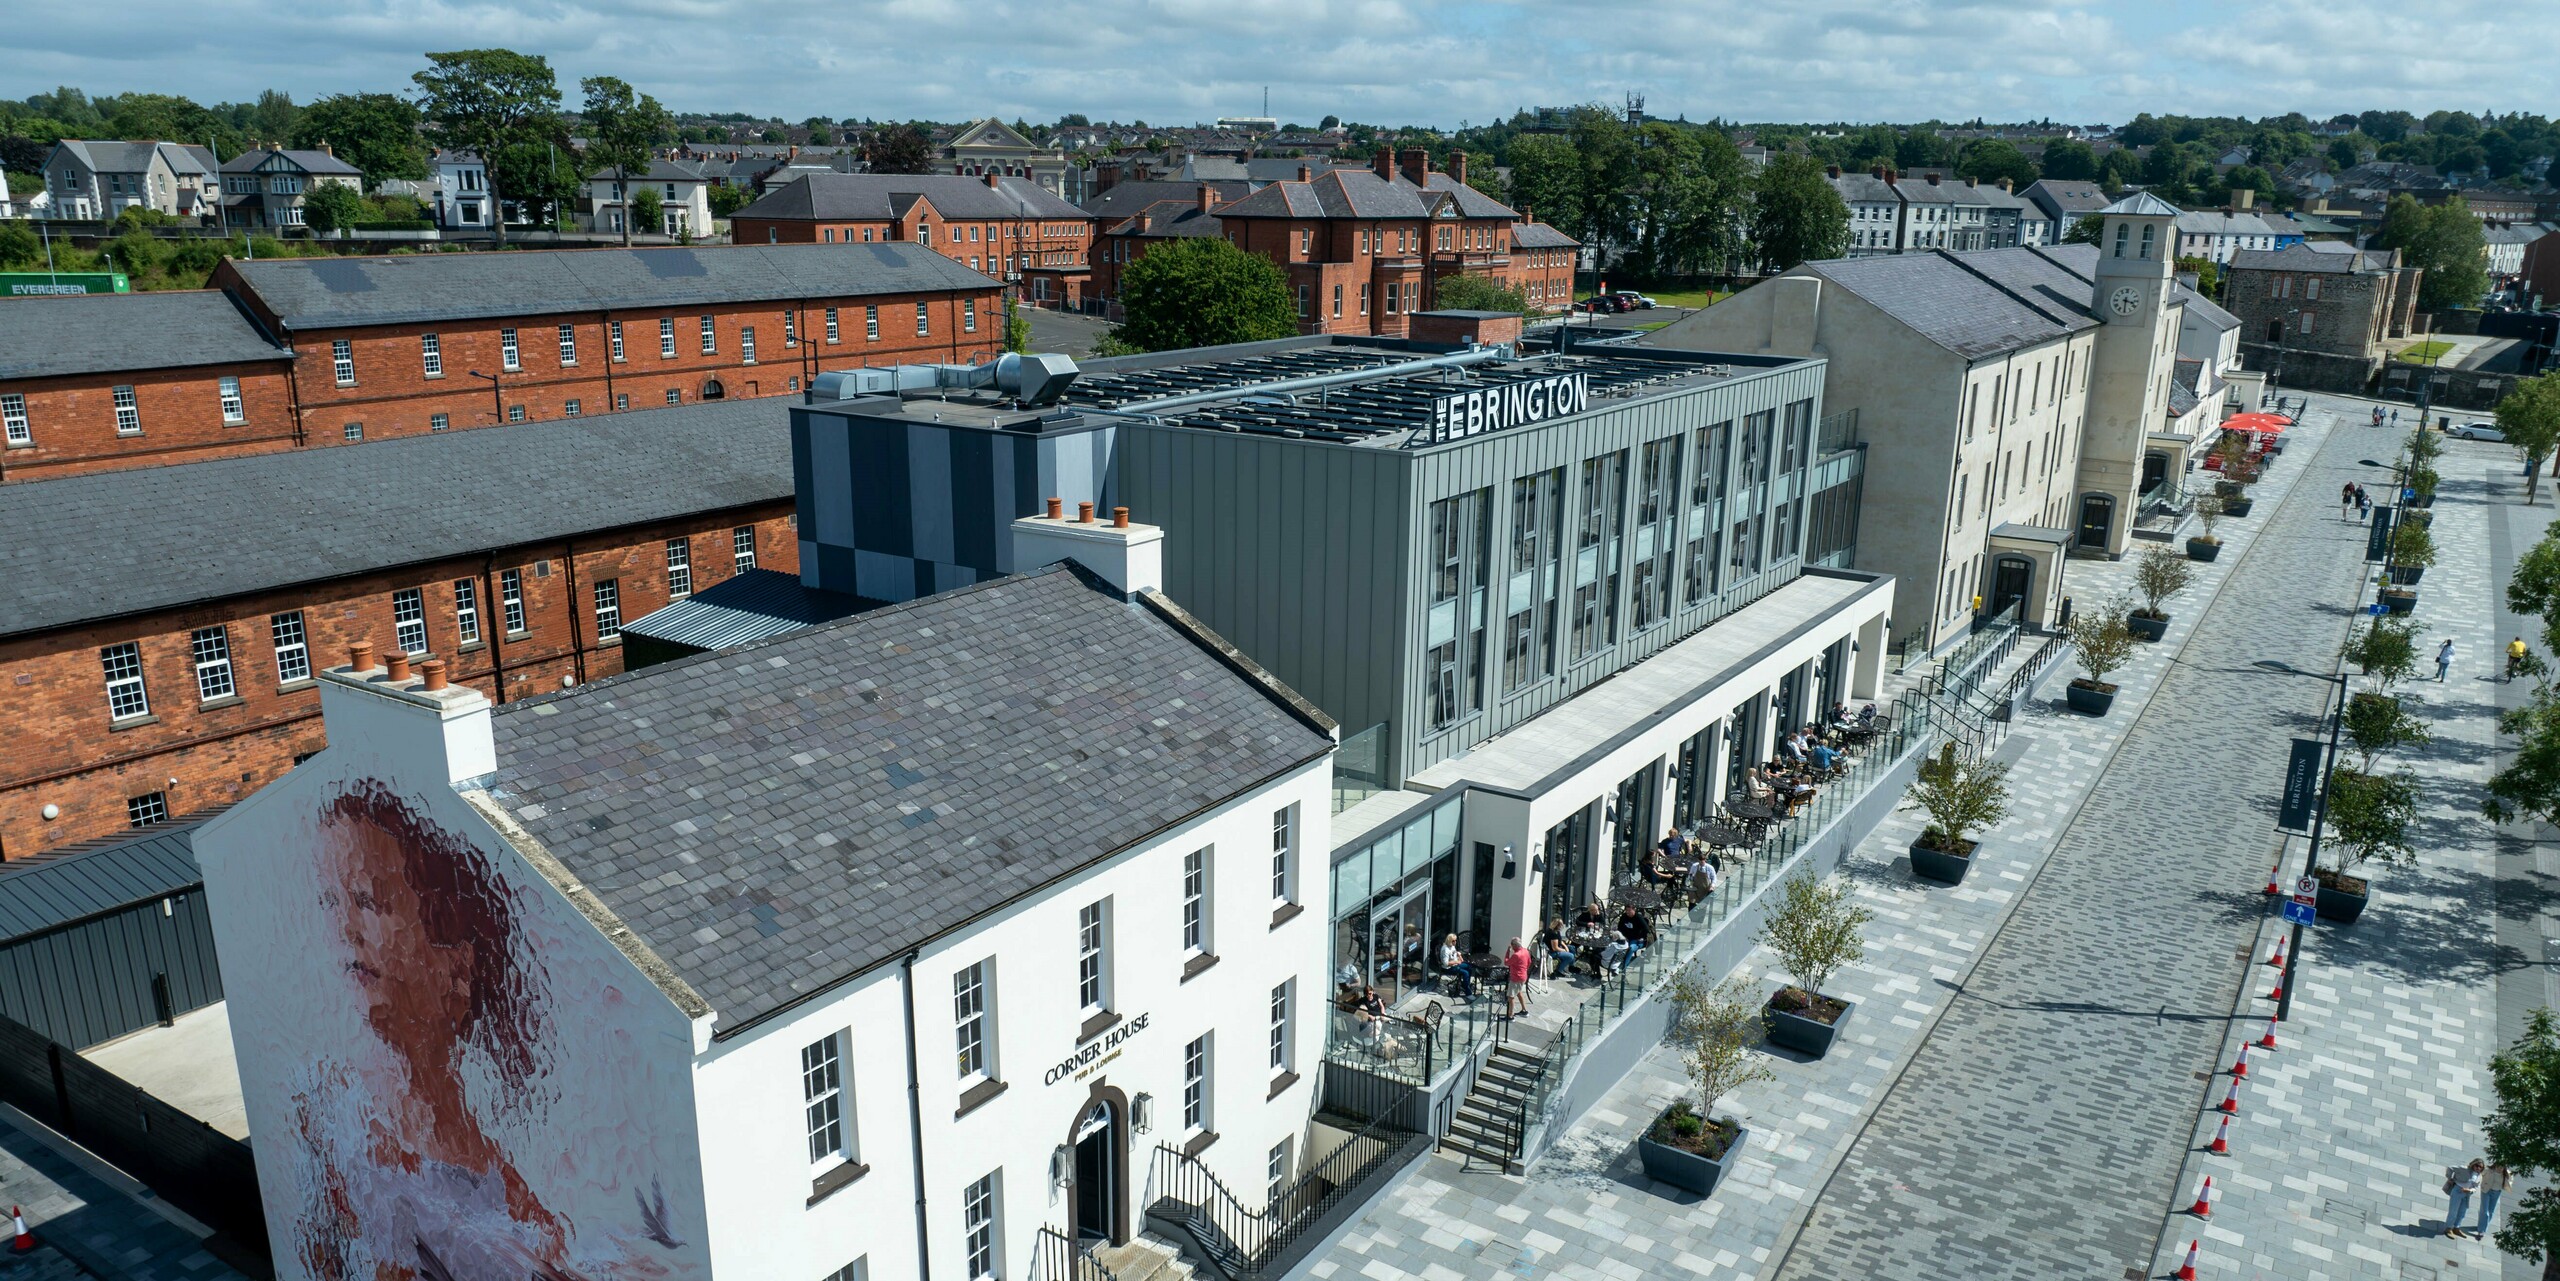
2071;192;2179;556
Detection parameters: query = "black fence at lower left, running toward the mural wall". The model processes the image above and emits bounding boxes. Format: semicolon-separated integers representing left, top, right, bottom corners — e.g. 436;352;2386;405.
0;1020;266;1255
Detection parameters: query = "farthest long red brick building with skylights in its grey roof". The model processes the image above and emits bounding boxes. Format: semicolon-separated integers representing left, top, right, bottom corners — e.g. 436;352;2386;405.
215;246;1004;443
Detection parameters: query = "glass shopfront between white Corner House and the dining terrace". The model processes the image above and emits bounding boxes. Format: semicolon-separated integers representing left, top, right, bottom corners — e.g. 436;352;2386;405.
1334;797;1480;1004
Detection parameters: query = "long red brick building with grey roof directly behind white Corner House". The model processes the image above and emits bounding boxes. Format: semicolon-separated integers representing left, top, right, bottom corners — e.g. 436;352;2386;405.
0;402;799;858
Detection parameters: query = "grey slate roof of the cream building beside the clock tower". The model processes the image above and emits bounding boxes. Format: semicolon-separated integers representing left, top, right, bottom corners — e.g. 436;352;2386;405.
1805;246;2097;361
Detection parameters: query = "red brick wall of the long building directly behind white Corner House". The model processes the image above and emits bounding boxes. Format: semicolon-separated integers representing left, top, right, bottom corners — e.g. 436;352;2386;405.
0;500;799;858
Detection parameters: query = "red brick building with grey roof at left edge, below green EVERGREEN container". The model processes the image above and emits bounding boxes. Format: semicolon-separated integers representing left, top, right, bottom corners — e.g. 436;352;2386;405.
0;290;294;482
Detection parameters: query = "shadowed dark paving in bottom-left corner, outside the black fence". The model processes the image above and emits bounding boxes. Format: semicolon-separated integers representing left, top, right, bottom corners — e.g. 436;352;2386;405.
0;1120;243;1281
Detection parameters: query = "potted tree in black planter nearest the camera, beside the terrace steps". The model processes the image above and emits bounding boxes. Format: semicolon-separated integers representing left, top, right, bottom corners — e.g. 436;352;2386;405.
1636;971;1774;1196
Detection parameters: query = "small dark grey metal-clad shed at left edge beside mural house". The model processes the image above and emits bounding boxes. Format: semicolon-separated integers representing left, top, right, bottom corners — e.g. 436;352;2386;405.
0;815;223;1048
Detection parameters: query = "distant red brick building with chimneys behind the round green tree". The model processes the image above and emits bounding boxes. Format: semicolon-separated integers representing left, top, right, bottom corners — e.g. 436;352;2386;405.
1093;149;1577;338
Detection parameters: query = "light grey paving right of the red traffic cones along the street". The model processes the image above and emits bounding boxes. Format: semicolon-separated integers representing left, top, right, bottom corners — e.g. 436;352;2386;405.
2150;420;2529;1281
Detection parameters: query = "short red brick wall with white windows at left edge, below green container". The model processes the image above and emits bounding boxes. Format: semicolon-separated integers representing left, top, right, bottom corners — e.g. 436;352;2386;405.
0;359;294;479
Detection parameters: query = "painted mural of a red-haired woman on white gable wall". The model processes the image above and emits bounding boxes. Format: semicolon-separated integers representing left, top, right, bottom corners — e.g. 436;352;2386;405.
280;781;707;1281
